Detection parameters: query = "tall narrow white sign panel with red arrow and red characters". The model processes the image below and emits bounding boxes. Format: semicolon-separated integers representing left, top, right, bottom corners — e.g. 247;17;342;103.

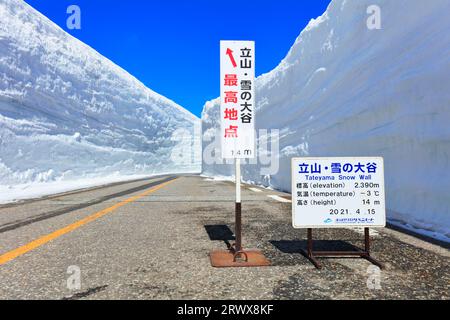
220;41;255;159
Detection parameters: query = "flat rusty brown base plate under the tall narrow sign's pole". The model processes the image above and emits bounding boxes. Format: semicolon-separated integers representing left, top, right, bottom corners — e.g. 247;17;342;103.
209;250;270;268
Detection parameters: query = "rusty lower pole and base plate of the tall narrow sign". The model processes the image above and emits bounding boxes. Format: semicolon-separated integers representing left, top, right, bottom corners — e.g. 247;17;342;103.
209;203;270;268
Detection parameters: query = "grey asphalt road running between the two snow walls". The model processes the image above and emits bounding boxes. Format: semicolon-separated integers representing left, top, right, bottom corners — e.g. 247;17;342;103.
0;176;450;299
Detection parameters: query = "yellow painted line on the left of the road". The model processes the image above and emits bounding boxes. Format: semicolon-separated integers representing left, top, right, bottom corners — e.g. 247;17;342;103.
0;178;178;266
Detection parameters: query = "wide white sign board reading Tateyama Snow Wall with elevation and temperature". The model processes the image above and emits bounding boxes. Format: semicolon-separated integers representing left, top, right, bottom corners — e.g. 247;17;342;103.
292;158;386;228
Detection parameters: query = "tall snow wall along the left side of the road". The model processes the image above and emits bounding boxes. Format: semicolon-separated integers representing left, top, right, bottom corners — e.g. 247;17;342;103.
0;0;201;202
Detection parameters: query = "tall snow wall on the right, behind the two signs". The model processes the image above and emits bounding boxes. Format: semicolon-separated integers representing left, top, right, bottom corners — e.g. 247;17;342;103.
202;0;450;241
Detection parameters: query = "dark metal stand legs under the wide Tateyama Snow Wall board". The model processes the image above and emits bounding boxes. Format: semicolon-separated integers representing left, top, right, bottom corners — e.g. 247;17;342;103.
302;228;385;269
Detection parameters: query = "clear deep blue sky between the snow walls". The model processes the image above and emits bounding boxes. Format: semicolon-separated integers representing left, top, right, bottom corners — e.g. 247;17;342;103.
26;0;330;116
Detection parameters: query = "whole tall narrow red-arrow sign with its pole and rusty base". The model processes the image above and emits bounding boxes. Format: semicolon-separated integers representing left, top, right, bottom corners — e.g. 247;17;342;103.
210;41;269;267
